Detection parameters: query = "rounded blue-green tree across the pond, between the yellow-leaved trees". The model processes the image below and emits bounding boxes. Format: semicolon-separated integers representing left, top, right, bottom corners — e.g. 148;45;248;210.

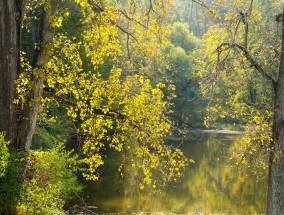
164;23;204;126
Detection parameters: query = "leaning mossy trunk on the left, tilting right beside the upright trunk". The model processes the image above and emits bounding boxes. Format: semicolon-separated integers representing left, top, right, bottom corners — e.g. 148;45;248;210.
17;0;59;151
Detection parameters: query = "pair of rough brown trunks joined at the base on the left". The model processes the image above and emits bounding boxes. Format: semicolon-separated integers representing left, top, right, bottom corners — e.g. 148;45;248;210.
0;0;59;150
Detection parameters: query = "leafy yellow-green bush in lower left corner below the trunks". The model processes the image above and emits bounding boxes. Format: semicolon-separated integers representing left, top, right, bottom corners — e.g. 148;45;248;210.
0;133;82;215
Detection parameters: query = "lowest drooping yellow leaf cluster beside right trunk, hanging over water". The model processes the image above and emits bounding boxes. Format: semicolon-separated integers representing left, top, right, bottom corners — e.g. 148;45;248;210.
230;111;272;178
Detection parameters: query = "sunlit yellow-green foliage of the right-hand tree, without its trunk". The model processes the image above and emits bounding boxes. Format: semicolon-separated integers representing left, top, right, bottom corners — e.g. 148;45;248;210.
194;0;282;173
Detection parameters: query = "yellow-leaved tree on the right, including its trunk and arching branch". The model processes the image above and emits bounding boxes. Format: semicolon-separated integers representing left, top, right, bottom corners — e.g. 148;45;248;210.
191;0;284;214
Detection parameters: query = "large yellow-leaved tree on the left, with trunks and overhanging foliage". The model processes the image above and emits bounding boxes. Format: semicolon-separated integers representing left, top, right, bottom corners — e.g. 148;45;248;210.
0;0;187;197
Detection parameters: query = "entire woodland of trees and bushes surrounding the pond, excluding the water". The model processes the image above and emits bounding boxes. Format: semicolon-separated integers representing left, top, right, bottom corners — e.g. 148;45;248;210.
0;0;284;214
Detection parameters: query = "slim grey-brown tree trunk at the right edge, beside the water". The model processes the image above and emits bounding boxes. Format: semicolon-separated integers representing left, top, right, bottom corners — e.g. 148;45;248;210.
267;13;284;215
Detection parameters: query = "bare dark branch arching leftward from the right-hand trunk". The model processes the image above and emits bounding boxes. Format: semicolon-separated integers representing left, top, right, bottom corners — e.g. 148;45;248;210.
216;42;276;84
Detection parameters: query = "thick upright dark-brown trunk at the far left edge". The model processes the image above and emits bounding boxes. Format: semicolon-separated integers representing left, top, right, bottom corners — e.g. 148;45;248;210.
0;0;22;146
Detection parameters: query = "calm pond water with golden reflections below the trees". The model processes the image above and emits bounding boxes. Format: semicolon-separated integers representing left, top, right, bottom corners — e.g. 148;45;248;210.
75;133;267;214
